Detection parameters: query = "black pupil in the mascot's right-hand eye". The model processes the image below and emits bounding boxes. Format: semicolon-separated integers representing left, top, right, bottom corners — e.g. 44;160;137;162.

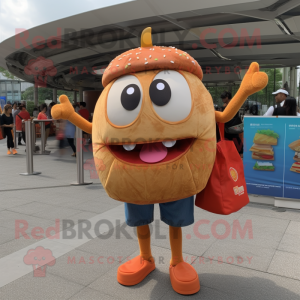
149;79;171;106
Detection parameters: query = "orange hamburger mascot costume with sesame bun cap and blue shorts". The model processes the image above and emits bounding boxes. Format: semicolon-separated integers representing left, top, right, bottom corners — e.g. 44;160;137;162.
52;27;268;295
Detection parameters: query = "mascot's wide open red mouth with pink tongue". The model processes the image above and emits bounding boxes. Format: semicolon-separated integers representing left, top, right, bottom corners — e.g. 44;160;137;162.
108;138;195;165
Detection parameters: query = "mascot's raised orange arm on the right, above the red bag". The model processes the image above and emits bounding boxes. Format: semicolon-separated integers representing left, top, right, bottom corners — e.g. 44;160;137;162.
215;62;268;123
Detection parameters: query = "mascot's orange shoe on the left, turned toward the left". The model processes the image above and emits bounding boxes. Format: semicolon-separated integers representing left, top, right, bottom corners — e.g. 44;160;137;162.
117;255;155;286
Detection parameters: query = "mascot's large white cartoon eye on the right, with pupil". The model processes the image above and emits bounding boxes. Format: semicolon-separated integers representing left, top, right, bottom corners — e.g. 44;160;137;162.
149;70;192;122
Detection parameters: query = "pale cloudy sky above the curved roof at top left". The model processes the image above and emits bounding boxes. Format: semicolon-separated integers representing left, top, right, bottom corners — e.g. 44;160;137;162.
0;0;132;43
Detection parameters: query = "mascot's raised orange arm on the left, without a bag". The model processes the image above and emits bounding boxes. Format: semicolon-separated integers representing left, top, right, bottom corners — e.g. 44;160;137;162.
51;95;92;133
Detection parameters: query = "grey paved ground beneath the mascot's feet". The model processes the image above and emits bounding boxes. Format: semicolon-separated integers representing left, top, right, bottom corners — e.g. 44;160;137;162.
0;140;300;300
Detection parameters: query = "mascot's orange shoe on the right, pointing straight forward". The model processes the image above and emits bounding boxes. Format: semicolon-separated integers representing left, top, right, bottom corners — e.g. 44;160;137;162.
169;262;200;295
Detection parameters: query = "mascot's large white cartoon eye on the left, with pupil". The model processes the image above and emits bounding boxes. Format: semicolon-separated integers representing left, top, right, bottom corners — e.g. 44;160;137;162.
107;75;143;126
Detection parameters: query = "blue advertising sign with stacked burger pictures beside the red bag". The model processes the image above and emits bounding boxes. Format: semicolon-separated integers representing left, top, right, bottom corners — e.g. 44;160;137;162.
243;117;300;199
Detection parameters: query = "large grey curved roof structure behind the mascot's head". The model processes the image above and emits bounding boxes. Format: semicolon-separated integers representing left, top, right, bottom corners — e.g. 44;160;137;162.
0;0;300;90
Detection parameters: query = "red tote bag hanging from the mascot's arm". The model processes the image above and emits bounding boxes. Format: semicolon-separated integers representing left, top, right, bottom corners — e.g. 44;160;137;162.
195;123;249;215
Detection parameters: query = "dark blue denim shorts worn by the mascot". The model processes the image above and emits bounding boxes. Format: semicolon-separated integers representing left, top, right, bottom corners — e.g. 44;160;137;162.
125;196;194;227
